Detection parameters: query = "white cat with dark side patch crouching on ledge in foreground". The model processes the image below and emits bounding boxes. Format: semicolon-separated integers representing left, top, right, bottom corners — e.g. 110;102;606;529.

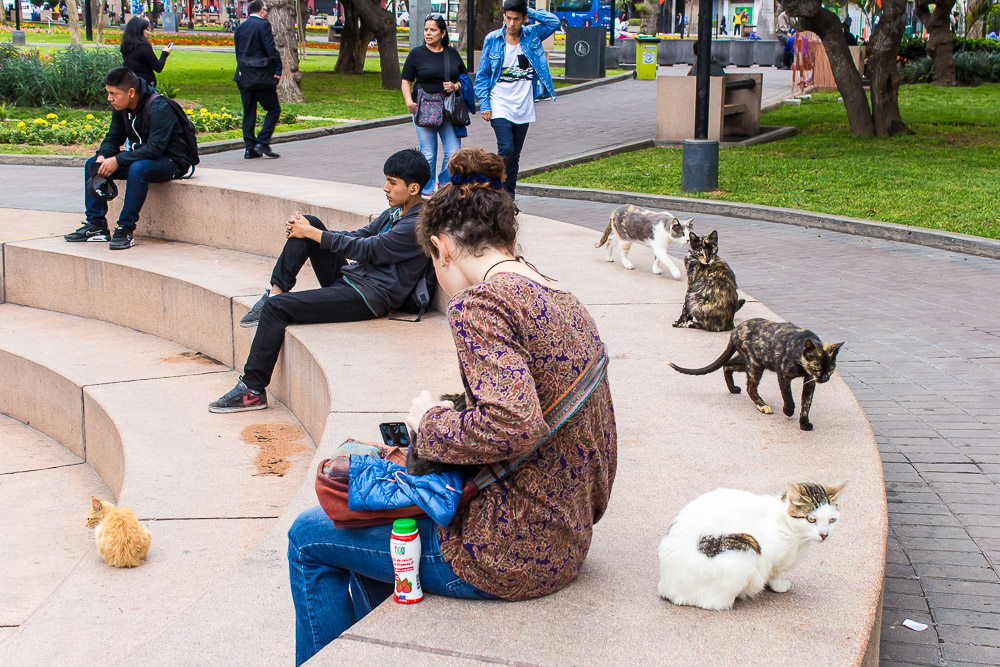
659;482;847;610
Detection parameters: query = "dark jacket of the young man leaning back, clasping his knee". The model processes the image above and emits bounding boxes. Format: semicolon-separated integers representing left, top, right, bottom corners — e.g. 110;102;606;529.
320;204;431;317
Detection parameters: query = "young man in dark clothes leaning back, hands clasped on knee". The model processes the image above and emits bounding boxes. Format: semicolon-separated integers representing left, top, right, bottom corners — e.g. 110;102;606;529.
208;149;434;412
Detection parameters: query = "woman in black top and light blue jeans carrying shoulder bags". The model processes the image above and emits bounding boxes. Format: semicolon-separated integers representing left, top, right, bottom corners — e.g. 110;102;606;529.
402;14;467;195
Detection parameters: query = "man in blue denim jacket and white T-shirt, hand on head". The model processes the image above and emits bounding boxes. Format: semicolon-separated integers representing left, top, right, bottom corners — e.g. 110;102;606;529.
473;0;559;197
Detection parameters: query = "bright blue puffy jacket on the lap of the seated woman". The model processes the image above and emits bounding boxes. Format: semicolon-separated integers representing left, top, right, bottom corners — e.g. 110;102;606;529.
347;454;465;527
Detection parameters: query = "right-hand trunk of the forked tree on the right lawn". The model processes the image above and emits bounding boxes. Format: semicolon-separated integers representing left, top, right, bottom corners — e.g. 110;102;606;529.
868;0;913;137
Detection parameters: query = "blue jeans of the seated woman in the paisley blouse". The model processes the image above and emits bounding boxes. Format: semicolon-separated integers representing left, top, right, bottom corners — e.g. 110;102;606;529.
288;505;497;665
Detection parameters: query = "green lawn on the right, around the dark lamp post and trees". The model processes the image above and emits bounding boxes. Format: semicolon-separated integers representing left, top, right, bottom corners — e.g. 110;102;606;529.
525;84;1000;238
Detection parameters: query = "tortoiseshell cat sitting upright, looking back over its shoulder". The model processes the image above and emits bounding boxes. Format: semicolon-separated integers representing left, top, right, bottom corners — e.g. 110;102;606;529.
674;231;746;331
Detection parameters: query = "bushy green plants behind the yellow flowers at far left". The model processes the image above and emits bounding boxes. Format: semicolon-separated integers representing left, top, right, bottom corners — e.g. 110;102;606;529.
0;46;122;107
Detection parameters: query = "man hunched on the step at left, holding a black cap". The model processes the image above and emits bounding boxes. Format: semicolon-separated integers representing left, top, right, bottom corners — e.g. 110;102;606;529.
63;67;192;250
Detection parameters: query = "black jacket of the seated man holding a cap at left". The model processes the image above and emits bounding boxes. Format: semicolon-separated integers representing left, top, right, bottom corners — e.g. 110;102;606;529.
97;79;190;171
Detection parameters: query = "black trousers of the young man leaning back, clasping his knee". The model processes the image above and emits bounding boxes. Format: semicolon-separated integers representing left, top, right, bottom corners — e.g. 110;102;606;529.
243;215;375;391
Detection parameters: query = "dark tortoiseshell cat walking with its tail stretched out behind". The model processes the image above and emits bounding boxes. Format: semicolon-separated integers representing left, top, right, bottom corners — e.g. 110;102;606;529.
669;318;843;431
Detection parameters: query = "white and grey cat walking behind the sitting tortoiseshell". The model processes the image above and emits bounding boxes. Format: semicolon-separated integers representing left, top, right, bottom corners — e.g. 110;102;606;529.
594;204;694;280
